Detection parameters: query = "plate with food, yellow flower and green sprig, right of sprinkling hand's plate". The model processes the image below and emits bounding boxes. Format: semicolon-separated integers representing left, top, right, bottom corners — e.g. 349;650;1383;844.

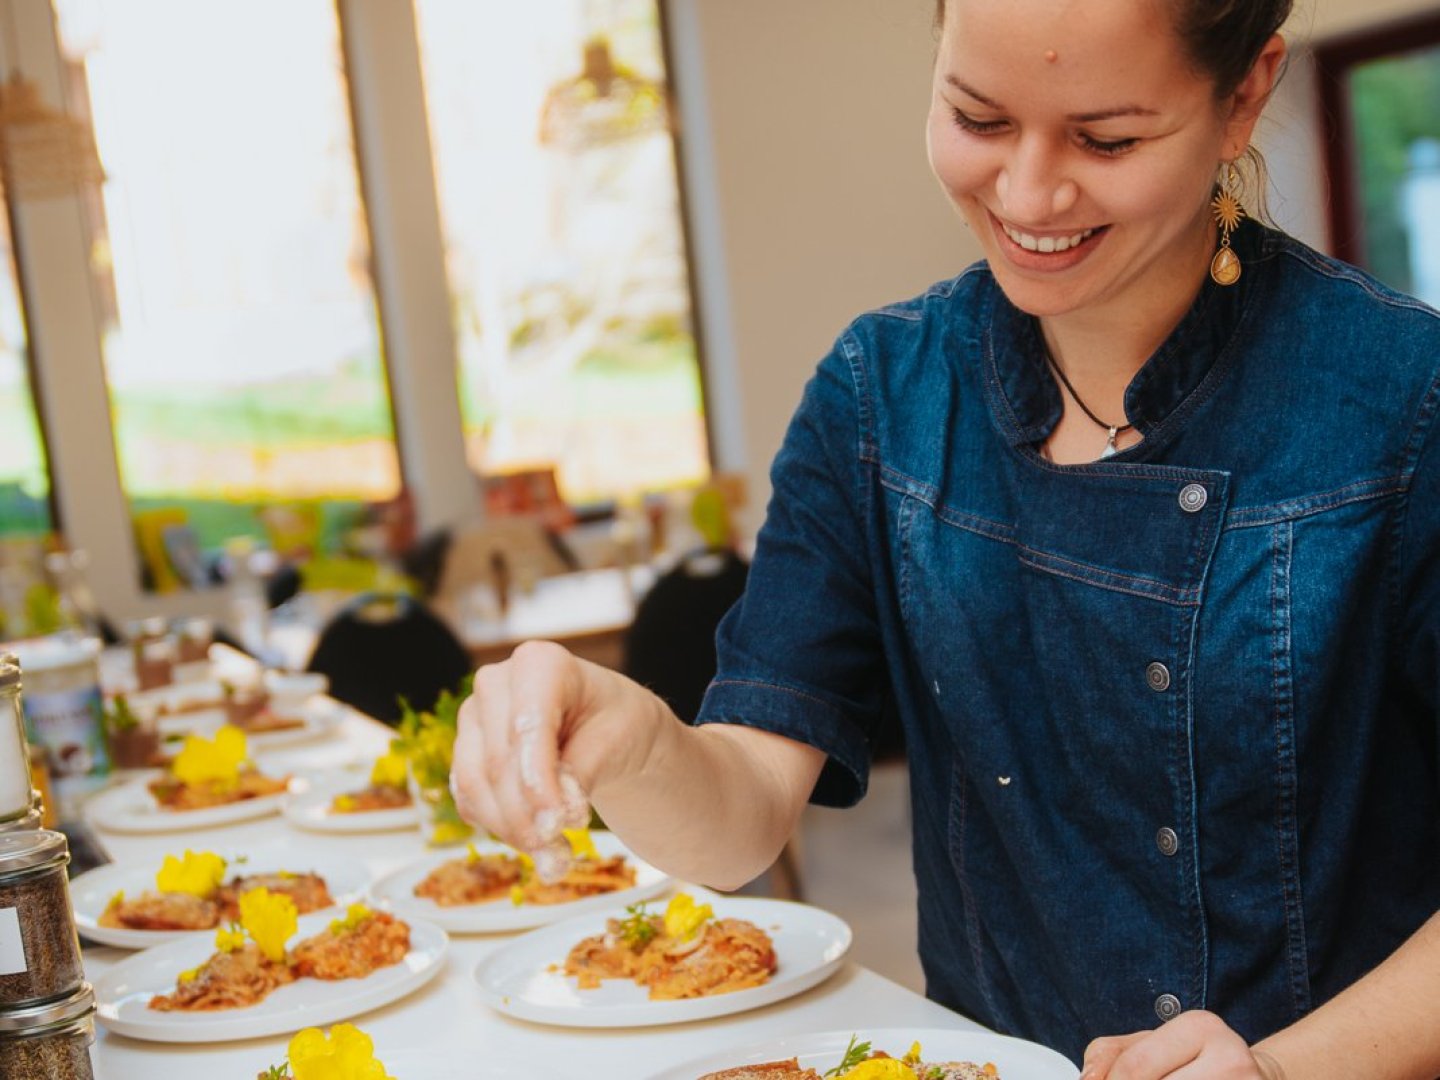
475;894;851;1027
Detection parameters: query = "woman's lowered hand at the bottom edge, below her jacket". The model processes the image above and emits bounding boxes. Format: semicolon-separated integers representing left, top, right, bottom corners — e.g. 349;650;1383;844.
1080;1009;1284;1080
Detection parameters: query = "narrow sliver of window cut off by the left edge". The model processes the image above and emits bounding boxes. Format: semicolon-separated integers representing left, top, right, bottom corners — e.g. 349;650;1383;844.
0;197;53;538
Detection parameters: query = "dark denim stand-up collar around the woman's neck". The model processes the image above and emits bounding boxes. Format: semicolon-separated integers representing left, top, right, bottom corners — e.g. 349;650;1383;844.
982;222;1263;449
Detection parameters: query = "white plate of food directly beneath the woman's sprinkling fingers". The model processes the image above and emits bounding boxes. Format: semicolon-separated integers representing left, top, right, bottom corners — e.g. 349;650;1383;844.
374;829;670;933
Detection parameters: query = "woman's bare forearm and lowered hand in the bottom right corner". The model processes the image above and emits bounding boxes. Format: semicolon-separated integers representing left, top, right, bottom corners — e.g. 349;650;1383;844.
1081;914;1440;1080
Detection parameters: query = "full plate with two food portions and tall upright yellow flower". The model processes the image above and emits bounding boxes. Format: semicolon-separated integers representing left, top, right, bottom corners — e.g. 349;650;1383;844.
95;910;446;1043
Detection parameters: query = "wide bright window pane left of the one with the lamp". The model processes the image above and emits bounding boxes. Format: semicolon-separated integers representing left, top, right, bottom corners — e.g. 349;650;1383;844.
56;0;399;570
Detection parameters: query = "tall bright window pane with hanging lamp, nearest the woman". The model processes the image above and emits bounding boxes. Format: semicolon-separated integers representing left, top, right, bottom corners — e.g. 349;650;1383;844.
416;0;708;501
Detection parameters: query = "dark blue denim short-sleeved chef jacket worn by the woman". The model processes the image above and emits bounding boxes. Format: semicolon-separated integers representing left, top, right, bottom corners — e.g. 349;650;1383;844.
701;225;1440;1060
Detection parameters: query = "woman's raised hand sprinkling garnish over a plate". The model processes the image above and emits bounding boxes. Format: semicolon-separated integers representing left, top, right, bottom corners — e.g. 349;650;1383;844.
451;641;668;851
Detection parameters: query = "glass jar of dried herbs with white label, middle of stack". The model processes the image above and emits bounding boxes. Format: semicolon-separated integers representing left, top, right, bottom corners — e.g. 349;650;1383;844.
0;829;85;1012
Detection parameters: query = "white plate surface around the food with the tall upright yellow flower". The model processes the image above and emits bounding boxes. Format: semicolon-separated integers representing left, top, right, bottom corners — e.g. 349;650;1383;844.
95;913;449;1043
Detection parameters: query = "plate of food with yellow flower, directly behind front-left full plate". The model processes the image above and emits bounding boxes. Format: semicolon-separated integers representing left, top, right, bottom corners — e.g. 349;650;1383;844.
71;850;369;949
